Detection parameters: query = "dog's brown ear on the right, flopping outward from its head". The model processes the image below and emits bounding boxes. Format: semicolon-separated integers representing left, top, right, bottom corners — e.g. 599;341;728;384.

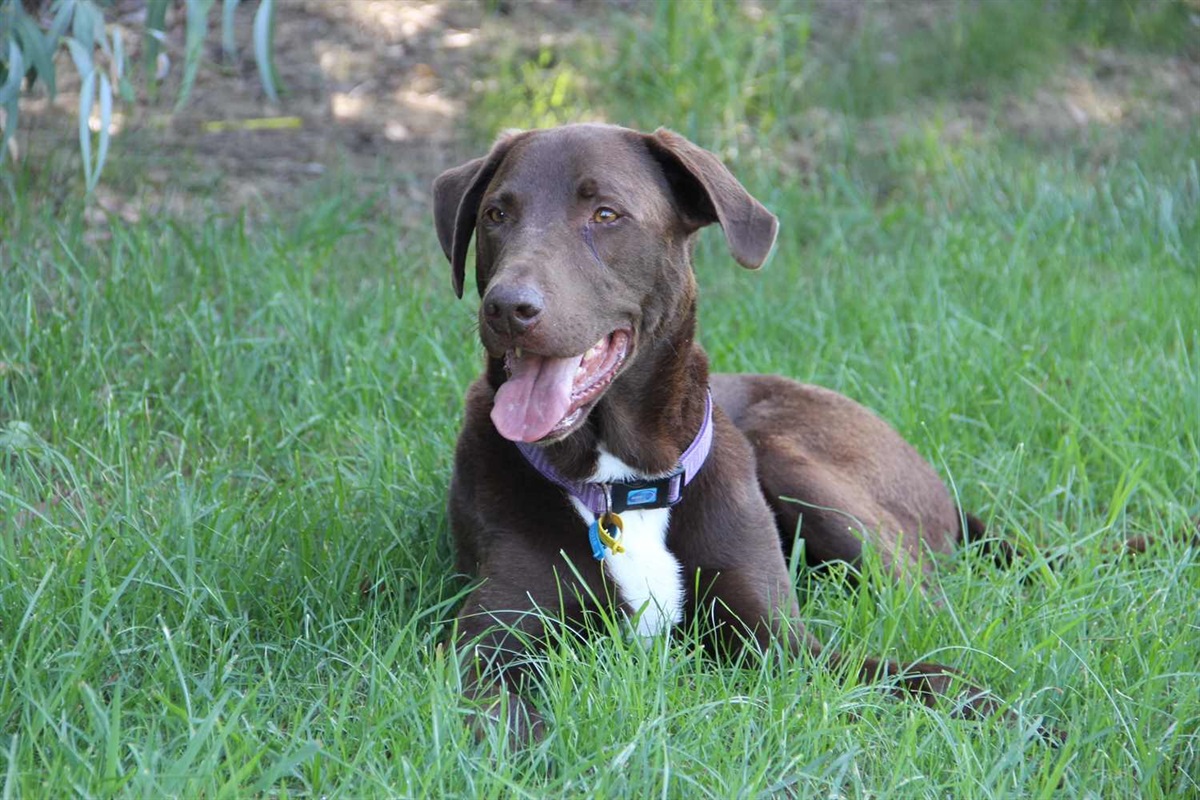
646;128;779;270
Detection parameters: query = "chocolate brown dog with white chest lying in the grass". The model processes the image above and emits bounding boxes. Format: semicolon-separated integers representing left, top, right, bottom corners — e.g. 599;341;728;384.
433;125;996;739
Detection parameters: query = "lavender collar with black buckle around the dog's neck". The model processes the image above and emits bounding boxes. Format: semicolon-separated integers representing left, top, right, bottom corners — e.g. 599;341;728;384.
516;391;713;516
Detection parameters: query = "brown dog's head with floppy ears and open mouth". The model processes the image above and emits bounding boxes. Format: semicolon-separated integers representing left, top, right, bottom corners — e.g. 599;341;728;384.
433;125;778;441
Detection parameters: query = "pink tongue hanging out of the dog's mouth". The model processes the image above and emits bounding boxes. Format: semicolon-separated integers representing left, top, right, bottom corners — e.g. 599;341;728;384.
492;355;582;441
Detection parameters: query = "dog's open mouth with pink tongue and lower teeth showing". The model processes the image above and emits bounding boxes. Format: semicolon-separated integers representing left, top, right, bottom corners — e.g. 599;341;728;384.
492;330;629;441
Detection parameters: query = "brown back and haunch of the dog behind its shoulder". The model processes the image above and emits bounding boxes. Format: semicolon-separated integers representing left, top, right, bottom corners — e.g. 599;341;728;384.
710;374;960;573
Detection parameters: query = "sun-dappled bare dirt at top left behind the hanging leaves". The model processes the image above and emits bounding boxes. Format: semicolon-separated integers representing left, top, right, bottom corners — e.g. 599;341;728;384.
10;0;590;221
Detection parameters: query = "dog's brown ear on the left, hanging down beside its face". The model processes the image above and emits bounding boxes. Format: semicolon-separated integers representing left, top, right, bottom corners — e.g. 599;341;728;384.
433;133;523;297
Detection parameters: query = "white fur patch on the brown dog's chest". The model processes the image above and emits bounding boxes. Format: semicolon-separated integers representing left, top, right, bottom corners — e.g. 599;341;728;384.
570;447;684;637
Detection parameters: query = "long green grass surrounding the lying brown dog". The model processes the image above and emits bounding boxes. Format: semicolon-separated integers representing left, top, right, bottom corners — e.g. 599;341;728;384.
0;4;1200;798
